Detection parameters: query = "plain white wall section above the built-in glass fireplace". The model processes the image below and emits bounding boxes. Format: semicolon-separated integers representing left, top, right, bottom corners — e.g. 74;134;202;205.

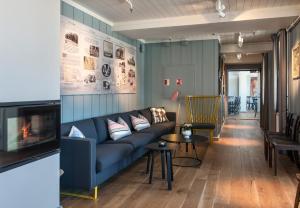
0;0;60;102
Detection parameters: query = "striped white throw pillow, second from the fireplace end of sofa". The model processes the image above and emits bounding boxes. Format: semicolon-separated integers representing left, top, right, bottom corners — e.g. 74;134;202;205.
107;117;131;141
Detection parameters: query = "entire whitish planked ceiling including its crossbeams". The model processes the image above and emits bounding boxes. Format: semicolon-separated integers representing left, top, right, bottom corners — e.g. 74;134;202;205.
73;0;300;49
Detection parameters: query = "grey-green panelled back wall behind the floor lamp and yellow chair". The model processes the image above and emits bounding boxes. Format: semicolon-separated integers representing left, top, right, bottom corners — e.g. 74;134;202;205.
145;40;219;122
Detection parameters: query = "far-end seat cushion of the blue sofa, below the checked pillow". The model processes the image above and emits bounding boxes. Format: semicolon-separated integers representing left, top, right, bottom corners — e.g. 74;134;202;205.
139;121;176;138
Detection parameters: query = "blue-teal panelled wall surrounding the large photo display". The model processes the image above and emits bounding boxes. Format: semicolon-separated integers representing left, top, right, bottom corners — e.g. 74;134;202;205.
61;1;145;123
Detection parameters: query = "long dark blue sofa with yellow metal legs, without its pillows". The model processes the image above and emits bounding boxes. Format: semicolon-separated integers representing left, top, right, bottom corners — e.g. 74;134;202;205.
61;108;176;190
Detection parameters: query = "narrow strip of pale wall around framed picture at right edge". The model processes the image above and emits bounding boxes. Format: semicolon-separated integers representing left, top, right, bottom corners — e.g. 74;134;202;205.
288;23;300;113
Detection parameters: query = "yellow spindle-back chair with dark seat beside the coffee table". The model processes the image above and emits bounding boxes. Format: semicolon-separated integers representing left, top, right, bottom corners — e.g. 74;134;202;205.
185;96;221;144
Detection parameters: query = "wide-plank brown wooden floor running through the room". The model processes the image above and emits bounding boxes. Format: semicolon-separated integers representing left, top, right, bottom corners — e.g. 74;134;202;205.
62;120;298;208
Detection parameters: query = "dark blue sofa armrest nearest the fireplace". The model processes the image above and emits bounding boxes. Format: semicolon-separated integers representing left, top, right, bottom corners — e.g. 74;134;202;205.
60;137;96;190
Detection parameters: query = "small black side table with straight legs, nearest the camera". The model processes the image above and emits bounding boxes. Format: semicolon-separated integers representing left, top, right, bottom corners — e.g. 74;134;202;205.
145;143;173;190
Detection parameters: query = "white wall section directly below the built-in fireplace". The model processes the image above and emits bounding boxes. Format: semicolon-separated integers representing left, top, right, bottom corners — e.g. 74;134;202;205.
0;154;59;208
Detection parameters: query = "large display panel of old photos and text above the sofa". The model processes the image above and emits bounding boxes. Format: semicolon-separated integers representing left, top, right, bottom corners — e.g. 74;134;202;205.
61;16;136;95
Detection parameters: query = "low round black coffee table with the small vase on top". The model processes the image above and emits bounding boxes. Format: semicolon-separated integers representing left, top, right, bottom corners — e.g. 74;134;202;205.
161;134;208;167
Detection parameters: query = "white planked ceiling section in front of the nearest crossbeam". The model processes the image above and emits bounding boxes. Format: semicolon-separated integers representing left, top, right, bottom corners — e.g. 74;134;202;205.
74;0;300;22
